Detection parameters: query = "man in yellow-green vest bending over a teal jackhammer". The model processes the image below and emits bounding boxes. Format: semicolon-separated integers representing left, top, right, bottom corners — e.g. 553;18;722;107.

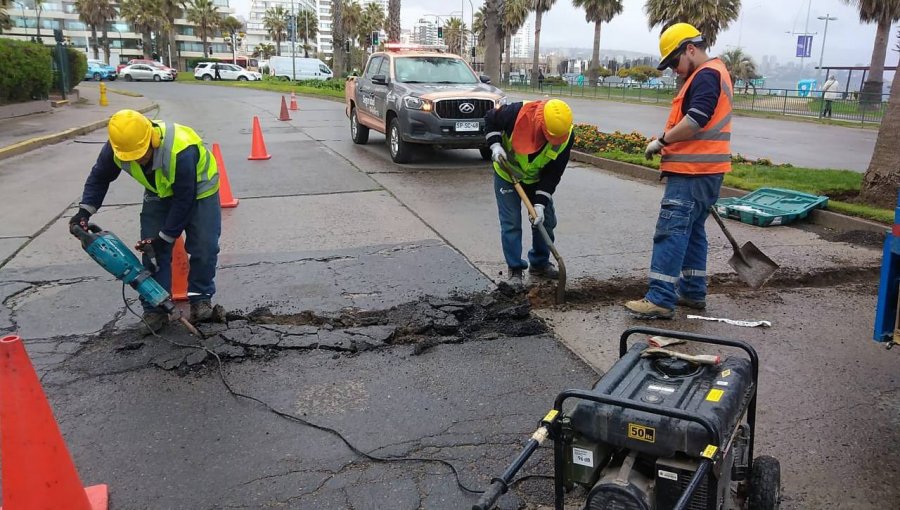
69;110;222;332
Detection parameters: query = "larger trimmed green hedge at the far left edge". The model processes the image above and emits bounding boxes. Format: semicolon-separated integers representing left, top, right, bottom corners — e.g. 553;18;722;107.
0;39;53;102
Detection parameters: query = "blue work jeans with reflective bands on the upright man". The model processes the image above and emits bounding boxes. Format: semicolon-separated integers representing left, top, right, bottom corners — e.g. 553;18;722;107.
645;174;724;309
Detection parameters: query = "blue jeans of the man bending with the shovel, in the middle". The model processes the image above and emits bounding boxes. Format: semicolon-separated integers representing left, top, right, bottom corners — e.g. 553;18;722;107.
494;172;556;269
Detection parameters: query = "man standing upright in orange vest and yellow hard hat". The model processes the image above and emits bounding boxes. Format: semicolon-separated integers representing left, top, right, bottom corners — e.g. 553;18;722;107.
625;23;733;319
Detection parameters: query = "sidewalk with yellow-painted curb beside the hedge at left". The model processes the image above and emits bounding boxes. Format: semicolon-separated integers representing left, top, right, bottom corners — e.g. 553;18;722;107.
0;82;155;160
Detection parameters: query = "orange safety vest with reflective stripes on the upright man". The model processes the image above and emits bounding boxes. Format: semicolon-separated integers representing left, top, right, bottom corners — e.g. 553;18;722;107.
659;58;734;175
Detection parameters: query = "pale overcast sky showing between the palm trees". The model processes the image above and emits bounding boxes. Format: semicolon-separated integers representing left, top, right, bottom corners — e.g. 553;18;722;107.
231;0;898;66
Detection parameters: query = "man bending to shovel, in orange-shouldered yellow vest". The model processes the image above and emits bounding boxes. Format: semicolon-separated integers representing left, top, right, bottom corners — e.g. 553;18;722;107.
485;99;574;285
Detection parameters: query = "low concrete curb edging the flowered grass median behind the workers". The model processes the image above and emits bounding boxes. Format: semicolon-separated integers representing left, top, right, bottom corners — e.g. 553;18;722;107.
572;150;890;234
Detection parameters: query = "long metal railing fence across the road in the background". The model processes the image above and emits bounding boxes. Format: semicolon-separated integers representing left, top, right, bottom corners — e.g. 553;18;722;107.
505;81;889;124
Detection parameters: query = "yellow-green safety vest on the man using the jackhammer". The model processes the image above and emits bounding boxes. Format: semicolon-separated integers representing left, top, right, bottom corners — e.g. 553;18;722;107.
113;122;219;200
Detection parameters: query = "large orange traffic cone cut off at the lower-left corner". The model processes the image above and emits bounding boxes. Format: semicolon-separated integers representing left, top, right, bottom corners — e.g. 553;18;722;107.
0;336;109;510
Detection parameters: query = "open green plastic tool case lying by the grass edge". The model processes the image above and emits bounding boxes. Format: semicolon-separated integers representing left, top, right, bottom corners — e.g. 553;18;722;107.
716;188;828;227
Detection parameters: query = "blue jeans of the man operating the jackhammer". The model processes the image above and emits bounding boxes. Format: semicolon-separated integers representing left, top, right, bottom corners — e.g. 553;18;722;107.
141;192;222;312
